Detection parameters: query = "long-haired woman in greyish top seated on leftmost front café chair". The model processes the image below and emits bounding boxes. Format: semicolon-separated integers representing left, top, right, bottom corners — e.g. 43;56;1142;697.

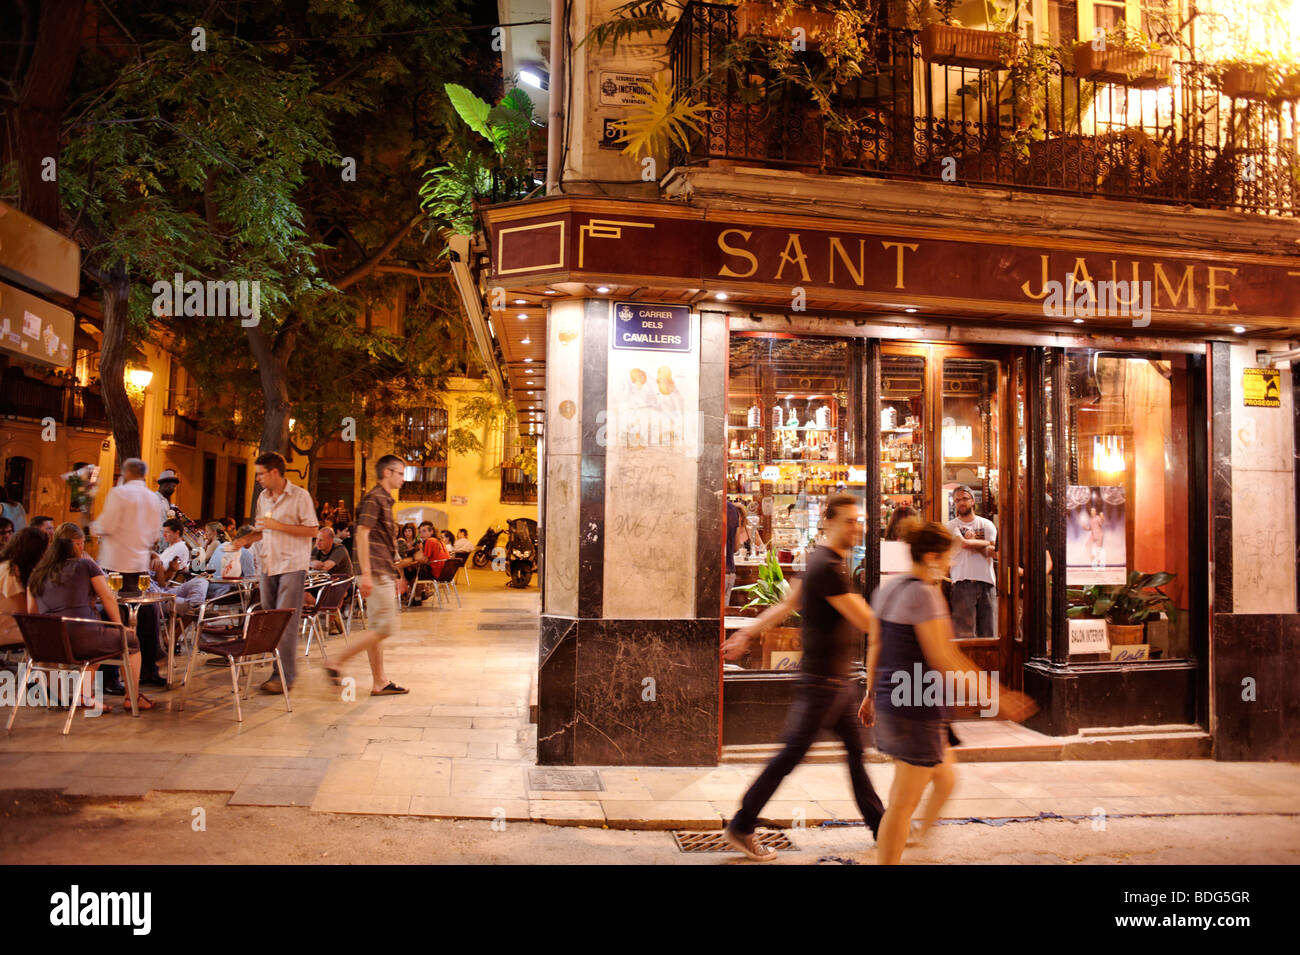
27;521;153;712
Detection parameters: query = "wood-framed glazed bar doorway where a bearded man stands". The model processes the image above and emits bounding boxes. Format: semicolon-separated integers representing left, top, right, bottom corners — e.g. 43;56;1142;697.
871;343;1024;696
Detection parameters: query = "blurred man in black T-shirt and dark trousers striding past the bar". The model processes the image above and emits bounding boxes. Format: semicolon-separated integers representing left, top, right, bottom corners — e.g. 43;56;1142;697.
723;494;884;863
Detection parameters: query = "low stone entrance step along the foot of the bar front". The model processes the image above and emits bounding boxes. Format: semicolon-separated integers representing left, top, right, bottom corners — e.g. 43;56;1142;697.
722;720;1213;765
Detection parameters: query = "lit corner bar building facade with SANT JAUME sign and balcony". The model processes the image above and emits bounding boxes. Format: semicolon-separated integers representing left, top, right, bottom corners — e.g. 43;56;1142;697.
460;0;1300;764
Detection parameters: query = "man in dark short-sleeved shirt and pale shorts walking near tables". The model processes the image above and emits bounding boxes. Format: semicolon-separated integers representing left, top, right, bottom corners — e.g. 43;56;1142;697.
325;455;410;696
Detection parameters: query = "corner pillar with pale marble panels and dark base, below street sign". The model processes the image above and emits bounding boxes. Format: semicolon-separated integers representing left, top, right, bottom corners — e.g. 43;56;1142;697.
537;299;727;765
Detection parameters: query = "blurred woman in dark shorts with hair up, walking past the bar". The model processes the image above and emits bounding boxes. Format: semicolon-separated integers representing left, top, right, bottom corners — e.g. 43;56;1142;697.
858;518;1036;865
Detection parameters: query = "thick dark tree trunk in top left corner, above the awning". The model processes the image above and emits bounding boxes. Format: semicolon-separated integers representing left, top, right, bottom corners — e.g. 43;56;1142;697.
16;0;86;229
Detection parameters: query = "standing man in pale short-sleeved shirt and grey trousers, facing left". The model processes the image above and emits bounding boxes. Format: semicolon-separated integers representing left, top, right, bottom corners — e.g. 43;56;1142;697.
231;451;320;693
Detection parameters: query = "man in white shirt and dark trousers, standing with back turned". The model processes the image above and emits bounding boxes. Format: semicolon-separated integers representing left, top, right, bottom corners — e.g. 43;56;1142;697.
91;457;166;693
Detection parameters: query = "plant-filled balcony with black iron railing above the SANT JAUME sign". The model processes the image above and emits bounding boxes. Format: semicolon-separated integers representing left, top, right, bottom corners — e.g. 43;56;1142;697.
668;3;1300;216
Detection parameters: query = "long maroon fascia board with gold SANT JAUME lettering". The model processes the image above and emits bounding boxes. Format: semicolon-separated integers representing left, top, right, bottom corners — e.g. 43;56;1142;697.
486;200;1300;324
